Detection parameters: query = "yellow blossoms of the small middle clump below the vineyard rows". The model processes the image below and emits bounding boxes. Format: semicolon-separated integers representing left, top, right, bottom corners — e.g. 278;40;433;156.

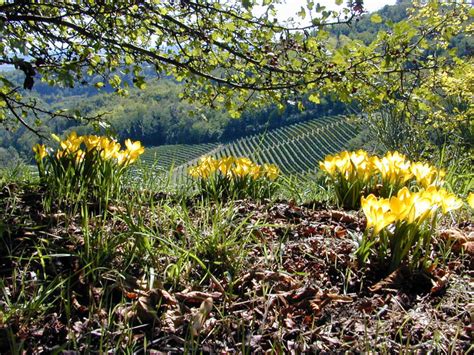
188;156;280;181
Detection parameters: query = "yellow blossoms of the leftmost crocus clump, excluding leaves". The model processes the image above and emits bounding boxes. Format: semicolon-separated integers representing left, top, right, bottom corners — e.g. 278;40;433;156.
33;132;145;165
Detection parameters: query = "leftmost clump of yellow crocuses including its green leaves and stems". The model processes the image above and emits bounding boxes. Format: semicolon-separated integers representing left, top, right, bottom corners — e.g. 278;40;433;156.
33;132;144;208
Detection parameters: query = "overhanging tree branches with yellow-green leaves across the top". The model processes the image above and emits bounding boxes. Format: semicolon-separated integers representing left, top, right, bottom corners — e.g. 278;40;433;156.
0;0;473;140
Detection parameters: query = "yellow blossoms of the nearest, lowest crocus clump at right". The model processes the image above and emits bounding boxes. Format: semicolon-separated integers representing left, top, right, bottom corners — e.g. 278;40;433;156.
361;186;463;234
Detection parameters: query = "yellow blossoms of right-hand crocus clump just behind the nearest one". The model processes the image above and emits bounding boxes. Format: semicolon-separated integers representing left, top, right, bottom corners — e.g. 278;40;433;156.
319;150;445;188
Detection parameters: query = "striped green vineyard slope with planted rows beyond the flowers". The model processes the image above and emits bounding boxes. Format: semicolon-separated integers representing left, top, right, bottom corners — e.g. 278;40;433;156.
142;116;359;175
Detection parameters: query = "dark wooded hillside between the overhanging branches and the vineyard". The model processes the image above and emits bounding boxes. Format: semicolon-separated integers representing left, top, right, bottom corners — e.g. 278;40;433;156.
0;79;345;163
